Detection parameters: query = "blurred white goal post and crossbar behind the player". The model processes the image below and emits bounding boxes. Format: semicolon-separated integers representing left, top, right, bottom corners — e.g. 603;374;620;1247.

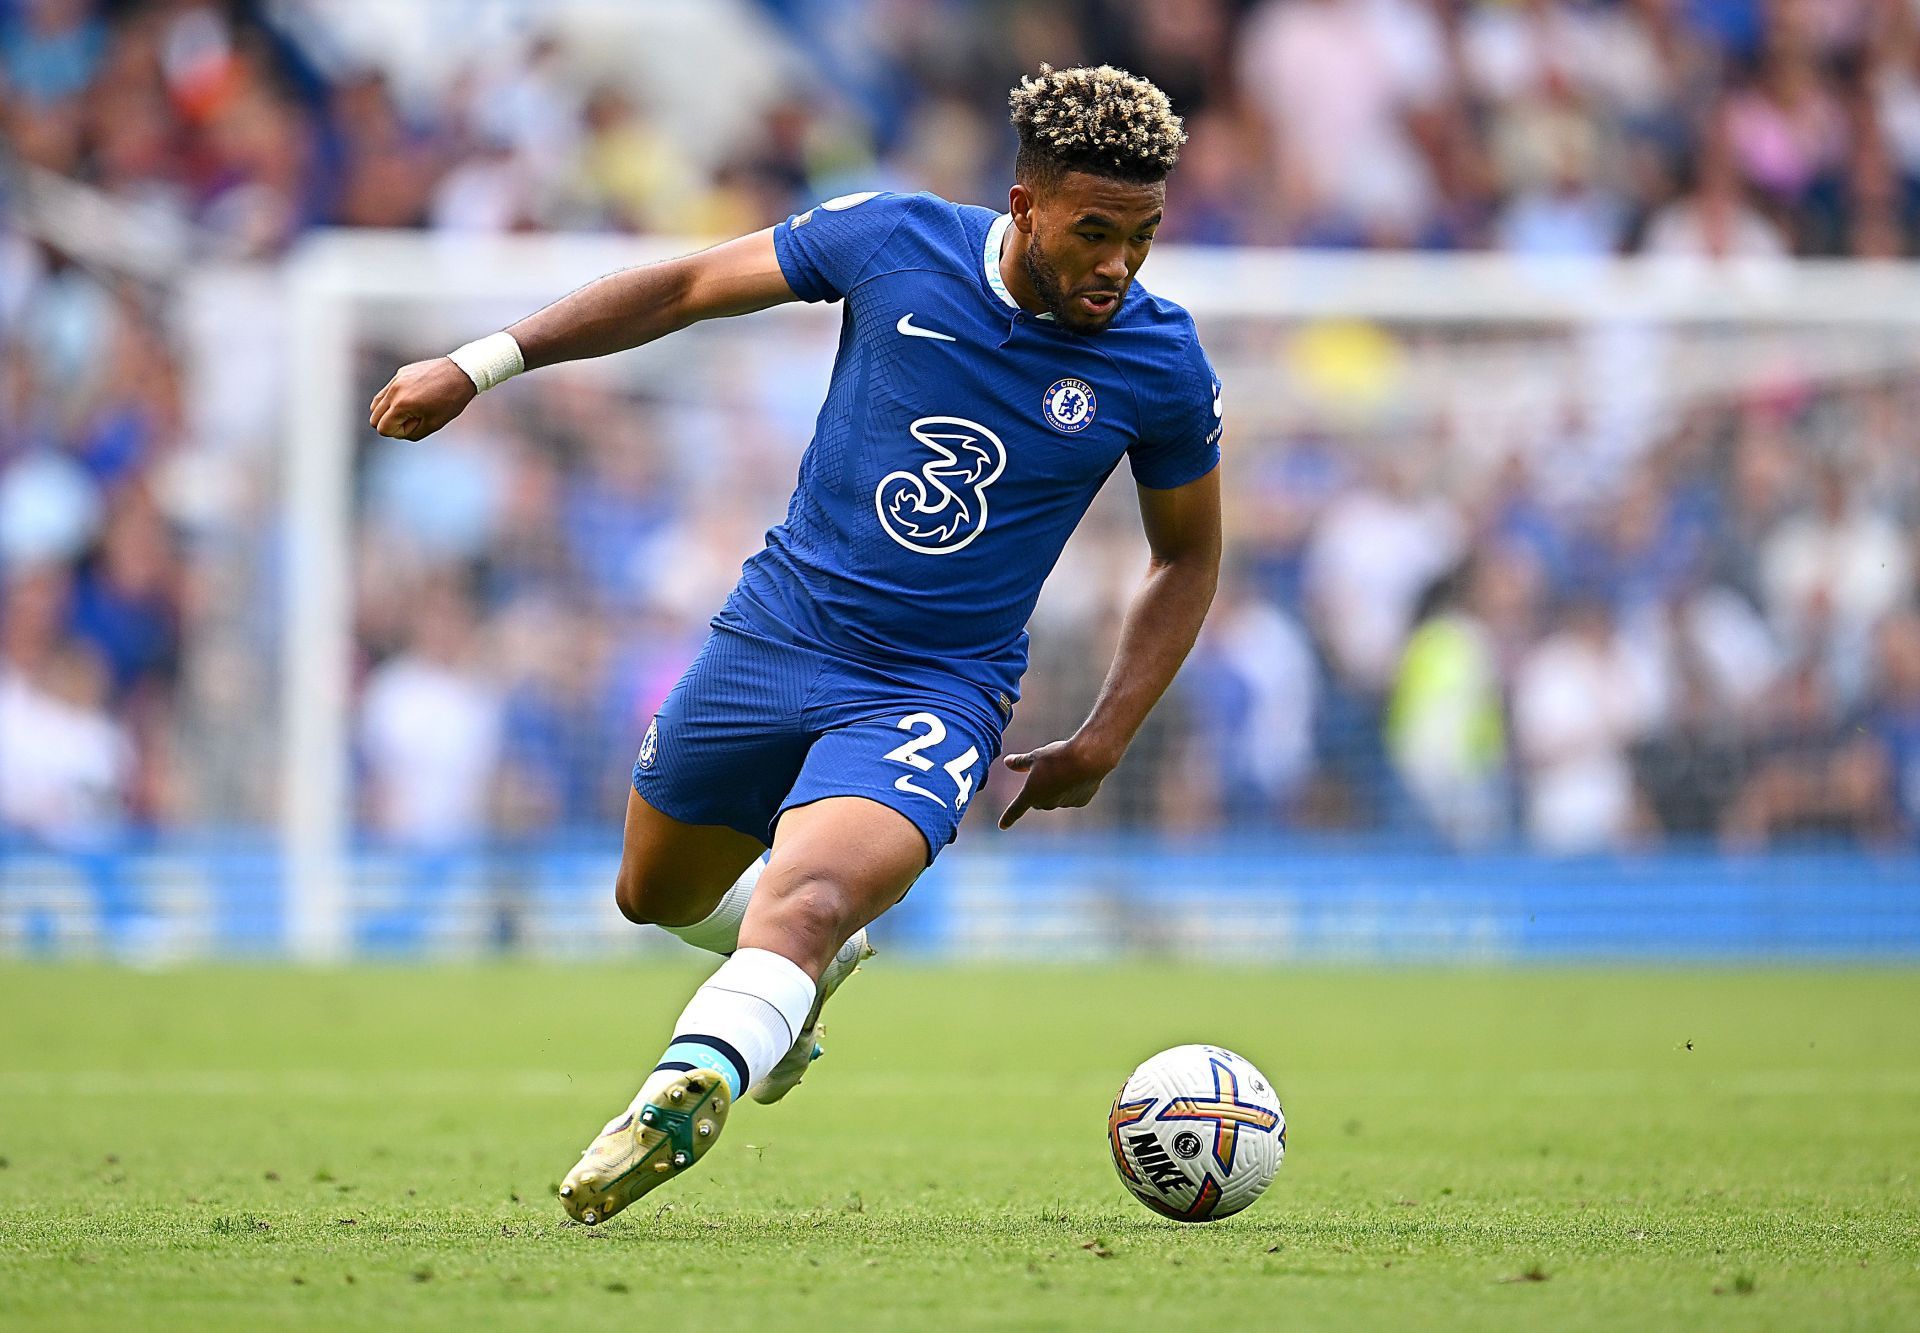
278;230;1920;962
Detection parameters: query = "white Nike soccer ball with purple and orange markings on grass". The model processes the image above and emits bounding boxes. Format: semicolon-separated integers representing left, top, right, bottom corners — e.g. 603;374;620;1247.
1106;1047;1286;1222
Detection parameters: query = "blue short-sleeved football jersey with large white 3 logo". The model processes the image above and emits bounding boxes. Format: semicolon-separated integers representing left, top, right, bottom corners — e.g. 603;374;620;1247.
722;194;1221;722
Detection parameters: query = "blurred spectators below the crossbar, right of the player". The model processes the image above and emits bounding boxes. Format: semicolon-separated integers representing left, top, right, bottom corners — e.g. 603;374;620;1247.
1183;376;1920;853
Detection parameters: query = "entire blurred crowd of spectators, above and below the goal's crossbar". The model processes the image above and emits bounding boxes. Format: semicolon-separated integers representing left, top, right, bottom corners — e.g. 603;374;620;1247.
0;0;1920;851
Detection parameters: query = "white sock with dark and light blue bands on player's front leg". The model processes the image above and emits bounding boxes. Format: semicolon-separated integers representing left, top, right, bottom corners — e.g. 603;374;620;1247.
643;949;816;1099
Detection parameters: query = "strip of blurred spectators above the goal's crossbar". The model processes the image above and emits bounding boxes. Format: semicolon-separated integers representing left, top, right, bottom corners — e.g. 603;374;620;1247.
18;0;1920;255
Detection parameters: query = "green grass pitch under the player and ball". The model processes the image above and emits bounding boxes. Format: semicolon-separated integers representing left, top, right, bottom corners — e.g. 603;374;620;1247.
0;957;1920;1329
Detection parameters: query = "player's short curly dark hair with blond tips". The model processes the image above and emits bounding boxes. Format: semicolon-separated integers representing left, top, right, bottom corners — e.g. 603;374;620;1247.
1006;65;1187;184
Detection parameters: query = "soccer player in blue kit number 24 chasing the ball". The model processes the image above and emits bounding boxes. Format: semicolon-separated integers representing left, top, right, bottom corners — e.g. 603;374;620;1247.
371;65;1221;1224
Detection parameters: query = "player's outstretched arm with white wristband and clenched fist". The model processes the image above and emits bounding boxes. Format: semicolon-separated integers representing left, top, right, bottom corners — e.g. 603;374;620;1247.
367;229;799;440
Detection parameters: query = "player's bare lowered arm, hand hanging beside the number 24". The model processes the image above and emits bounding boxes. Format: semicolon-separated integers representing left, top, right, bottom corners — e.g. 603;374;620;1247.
1000;467;1219;828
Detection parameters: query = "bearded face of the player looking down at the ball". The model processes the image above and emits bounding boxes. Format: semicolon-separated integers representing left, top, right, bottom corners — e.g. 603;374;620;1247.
1014;171;1167;332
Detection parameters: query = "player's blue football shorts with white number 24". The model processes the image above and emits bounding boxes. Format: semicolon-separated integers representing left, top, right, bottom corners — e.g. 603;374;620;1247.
634;624;1002;864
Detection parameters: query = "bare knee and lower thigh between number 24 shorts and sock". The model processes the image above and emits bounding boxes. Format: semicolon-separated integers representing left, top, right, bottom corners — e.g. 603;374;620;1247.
739;795;927;978
